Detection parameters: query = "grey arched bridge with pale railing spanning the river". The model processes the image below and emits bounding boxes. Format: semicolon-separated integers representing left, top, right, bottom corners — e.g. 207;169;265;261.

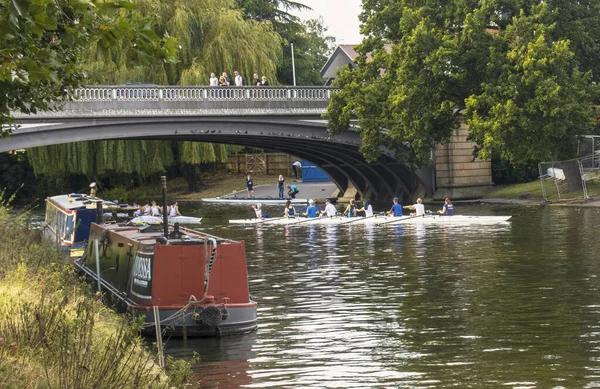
0;86;492;201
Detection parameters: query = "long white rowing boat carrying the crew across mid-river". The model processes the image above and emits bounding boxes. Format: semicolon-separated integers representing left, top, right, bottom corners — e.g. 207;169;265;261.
229;215;511;225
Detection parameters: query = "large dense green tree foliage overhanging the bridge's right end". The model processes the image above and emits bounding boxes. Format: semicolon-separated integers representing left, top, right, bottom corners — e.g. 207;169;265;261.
328;0;600;164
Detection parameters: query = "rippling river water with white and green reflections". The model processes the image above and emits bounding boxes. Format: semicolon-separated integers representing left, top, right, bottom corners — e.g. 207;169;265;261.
166;205;600;388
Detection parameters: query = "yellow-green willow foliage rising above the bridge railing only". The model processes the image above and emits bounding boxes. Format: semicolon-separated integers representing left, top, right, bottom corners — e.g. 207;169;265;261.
81;0;281;85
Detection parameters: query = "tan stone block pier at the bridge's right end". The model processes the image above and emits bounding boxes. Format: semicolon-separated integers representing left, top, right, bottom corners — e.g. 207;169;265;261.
433;123;494;200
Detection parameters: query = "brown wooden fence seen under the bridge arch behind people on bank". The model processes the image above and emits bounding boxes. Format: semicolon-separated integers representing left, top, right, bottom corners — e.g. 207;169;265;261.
225;153;300;176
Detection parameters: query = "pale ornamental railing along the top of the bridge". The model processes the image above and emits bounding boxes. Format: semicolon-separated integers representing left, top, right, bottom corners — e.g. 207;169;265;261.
73;86;335;101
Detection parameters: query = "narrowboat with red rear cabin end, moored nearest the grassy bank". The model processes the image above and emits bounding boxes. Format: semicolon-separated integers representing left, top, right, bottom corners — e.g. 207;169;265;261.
75;223;257;336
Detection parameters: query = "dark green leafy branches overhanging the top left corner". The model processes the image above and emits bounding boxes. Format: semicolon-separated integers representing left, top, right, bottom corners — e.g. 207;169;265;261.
0;0;176;129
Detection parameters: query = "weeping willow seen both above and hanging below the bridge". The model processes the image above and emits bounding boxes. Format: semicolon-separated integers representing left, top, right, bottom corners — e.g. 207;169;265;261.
30;0;281;190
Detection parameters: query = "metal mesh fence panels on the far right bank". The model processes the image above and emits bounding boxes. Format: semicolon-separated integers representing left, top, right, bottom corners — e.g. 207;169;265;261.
538;154;600;202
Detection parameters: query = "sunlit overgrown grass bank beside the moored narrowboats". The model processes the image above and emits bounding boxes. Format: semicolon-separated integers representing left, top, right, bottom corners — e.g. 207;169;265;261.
0;204;199;389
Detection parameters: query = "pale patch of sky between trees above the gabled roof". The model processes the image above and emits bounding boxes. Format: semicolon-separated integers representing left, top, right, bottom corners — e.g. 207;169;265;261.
293;0;362;44
